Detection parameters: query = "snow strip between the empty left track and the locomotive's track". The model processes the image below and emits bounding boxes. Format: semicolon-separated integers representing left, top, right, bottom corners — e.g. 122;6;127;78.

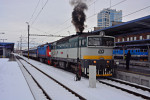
19;55;143;100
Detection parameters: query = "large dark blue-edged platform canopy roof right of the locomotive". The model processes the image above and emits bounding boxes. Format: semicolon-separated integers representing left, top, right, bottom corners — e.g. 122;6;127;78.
93;15;150;36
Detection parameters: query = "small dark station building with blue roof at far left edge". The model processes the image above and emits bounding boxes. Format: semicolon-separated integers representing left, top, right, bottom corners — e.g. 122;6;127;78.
0;42;14;58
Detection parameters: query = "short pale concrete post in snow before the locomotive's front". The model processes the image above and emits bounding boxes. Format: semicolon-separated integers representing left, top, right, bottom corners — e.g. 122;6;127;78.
89;65;96;88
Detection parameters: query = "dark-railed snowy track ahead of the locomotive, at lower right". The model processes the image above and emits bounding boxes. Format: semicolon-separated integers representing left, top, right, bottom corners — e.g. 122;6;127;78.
98;78;150;100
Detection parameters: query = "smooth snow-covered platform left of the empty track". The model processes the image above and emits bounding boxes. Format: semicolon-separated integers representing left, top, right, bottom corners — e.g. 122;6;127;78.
0;58;34;100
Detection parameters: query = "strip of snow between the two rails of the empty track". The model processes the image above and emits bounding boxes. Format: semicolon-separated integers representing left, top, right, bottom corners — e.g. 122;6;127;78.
21;60;79;100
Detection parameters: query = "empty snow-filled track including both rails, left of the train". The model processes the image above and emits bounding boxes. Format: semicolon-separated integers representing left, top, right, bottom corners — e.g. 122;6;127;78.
17;57;86;100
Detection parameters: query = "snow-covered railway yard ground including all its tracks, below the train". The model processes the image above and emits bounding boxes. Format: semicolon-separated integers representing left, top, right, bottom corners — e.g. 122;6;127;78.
0;54;150;100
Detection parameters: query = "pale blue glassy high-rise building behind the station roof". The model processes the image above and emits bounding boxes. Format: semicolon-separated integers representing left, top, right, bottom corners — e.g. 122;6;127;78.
97;8;122;28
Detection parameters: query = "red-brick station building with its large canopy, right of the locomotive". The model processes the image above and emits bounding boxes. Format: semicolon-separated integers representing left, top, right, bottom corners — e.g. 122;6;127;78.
95;15;150;61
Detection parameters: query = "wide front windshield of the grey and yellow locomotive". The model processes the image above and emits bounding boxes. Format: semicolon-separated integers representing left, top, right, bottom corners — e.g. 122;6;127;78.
88;37;114;46
